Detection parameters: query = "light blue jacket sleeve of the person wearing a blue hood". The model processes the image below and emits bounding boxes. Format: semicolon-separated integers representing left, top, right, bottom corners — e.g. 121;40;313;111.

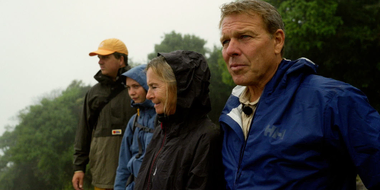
114;114;136;190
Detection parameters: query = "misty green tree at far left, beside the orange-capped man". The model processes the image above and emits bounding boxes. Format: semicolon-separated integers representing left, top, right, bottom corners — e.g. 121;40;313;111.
0;81;90;190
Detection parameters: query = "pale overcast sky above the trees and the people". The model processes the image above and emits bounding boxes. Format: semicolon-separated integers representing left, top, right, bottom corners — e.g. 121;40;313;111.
0;0;232;135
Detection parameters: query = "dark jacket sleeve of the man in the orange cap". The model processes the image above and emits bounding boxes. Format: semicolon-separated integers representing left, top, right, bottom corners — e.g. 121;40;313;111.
73;92;93;172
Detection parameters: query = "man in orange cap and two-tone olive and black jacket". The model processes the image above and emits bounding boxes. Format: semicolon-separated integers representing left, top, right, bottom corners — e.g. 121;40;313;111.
72;38;136;190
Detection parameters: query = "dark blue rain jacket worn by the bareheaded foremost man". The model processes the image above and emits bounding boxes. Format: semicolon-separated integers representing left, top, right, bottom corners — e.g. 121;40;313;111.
219;58;380;190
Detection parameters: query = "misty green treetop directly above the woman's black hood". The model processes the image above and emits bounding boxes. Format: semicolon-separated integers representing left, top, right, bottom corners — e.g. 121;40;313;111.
148;31;208;60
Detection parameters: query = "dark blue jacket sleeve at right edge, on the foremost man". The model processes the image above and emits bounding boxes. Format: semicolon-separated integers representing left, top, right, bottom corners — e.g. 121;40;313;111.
330;87;380;189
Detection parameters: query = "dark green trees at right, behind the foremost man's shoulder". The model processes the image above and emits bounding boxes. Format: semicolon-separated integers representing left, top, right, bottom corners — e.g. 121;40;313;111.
268;0;380;110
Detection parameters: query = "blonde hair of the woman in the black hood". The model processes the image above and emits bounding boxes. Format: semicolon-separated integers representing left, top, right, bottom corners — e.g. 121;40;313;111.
145;56;177;115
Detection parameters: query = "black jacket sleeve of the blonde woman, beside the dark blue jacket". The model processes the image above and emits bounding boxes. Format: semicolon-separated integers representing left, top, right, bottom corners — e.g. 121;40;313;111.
186;126;225;190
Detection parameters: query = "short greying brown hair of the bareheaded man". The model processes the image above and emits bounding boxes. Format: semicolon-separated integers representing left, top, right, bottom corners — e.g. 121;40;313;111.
219;0;285;55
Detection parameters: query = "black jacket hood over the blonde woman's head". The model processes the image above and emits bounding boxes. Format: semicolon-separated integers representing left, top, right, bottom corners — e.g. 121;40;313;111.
158;50;211;113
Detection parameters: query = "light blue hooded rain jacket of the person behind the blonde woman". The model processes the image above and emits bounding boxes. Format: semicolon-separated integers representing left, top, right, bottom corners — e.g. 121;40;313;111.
114;64;156;190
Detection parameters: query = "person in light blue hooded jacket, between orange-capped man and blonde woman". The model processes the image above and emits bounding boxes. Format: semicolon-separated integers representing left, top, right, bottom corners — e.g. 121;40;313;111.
114;64;156;190
